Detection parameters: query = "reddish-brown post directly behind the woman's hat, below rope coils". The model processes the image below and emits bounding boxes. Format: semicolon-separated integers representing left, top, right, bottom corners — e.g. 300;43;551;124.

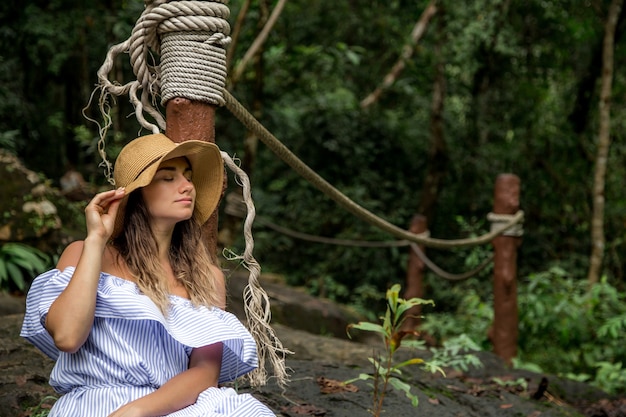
165;97;218;260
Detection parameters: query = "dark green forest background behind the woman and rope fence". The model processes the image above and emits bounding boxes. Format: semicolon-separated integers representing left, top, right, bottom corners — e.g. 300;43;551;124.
0;0;626;392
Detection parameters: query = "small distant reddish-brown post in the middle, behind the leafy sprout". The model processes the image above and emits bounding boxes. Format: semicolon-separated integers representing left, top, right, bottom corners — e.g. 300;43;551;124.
402;214;428;332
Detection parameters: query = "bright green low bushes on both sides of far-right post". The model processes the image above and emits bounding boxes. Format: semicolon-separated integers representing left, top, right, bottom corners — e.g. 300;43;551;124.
421;267;626;394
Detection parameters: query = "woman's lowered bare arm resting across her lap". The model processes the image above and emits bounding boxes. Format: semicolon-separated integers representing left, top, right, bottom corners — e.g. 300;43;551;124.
109;343;223;417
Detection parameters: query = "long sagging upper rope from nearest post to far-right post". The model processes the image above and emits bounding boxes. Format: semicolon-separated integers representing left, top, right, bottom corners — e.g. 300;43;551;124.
224;90;524;249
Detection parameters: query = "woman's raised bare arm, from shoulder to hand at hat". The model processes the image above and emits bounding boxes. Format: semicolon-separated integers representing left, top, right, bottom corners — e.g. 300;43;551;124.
46;189;124;353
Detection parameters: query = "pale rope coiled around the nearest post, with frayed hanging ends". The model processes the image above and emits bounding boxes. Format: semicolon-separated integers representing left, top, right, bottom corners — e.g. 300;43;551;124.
92;0;290;385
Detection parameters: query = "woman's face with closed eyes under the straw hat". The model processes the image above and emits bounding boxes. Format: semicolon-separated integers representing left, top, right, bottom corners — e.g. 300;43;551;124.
141;157;196;230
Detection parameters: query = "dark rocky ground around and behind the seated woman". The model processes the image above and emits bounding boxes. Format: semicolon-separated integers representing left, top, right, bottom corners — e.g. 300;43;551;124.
0;274;626;417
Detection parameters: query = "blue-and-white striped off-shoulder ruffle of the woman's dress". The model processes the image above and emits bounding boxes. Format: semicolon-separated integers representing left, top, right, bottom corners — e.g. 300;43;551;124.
21;267;258;383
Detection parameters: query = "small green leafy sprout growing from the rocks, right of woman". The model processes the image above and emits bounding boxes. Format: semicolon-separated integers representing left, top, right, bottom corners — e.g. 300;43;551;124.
346;284;443;417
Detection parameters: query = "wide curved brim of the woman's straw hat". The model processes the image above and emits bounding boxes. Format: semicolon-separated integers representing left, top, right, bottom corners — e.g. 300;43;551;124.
111;140;224;238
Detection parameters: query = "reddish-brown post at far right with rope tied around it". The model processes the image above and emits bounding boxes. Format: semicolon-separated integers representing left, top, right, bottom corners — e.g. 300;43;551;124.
489;174;521;365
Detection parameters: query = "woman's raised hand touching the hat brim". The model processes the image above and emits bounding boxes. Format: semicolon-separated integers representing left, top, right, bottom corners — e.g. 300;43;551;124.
85;187;126;241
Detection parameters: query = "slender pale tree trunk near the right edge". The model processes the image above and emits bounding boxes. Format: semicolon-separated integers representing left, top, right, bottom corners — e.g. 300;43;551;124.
587;0;624;285
